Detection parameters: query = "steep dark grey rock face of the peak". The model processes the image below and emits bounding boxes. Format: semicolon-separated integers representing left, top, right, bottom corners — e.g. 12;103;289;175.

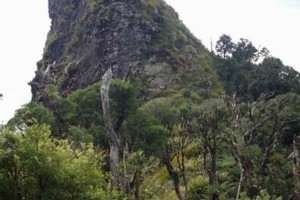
30;0;207;101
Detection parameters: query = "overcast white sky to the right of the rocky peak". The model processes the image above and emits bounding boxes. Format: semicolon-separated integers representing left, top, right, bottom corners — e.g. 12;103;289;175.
166;0;300;71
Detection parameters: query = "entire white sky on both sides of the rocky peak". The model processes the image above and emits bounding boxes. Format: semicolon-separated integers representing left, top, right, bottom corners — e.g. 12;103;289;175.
0;0;300;123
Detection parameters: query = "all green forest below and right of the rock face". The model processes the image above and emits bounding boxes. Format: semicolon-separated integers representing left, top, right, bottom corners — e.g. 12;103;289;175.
0;30;300;200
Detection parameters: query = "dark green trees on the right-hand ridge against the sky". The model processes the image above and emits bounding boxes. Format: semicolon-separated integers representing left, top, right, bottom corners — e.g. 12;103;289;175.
213;35;300;98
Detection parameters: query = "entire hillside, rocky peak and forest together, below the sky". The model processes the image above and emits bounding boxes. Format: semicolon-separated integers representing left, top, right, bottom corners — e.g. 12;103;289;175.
0;0;300;200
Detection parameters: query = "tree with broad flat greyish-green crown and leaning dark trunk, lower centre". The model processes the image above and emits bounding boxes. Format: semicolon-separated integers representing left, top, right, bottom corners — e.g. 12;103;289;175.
142;98;194;199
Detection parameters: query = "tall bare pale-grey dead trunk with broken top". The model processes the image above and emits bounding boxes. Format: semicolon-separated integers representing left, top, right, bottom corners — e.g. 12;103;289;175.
101;69;120;189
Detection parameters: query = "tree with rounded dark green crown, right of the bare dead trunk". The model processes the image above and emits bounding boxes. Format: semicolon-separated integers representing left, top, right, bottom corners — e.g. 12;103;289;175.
122;108;167;200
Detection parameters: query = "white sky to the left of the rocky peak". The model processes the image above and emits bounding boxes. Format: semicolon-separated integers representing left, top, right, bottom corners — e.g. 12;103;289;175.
0;0;50;123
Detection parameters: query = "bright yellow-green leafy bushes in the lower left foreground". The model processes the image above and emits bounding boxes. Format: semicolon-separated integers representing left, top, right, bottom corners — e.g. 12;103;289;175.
0;125;119;200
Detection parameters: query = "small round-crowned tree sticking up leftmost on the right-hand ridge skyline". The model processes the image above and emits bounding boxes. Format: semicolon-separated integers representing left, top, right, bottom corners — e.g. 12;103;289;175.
216;34;235;59
